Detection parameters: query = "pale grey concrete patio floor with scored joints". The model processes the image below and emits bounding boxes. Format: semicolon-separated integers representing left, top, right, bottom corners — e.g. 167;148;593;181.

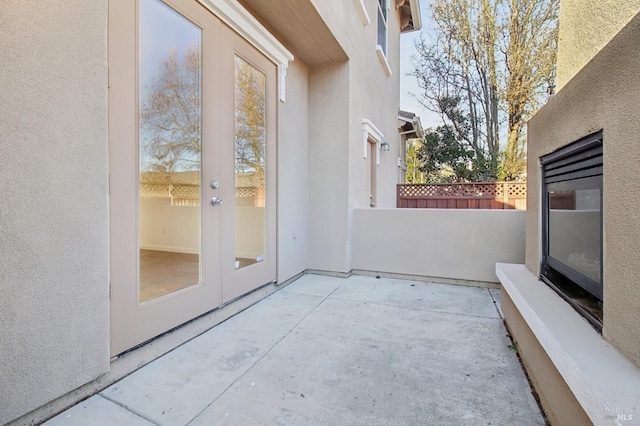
45;275;545;426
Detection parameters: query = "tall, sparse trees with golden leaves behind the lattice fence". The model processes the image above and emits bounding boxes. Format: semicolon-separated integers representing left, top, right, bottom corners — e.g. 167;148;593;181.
414;0;558;179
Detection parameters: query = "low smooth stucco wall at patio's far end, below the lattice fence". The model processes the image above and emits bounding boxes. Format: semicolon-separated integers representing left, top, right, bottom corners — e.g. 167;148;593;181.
353;209;525;283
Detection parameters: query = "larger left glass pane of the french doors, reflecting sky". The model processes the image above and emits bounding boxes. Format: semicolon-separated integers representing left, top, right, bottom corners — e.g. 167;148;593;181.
138;0;202;302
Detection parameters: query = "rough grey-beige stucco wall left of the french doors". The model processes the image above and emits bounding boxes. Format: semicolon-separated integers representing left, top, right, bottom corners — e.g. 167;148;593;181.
0;0;109;424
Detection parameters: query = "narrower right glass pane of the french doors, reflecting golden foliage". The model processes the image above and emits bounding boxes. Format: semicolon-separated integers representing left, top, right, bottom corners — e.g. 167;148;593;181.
235;55;267;269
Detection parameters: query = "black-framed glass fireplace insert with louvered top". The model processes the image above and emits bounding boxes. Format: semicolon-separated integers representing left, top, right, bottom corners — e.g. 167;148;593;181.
540;132;603;330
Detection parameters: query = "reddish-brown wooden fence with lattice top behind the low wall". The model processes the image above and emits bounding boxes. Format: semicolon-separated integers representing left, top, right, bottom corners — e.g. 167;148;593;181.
396;182;527;210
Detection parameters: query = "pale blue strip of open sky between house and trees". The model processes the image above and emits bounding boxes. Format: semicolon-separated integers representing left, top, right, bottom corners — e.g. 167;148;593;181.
400;0;440;128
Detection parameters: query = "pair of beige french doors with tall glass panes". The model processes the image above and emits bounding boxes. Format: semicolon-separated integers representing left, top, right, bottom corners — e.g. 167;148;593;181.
109;0;277;355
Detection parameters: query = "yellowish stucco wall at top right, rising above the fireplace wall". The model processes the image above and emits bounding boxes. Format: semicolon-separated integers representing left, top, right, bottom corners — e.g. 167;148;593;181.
556;0;640;90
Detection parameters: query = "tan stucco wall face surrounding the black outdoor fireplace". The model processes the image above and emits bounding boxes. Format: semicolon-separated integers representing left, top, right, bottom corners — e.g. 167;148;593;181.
526;11;640;366
